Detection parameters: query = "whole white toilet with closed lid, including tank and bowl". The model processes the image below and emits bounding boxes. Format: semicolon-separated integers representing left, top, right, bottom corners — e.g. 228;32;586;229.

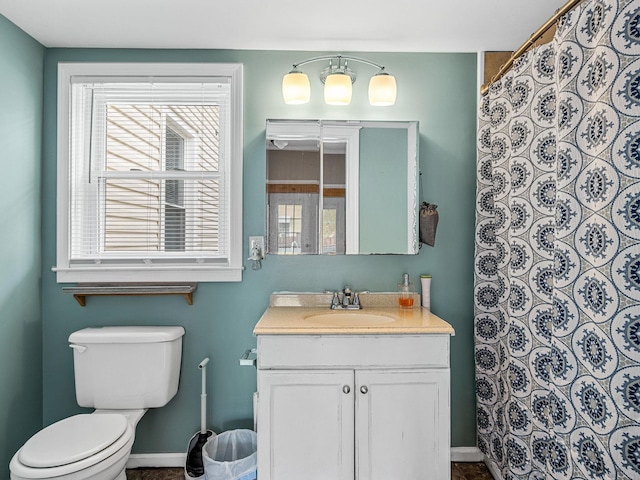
9;326;184;480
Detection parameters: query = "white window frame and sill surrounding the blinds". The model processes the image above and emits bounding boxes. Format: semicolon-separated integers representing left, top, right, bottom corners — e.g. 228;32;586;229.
53;62;244;283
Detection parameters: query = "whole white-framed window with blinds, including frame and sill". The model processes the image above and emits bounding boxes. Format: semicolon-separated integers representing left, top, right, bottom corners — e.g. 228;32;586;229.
54;63;242;282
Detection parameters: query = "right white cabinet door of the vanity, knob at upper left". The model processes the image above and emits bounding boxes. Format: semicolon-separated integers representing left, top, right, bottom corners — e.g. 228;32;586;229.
356;369;451;480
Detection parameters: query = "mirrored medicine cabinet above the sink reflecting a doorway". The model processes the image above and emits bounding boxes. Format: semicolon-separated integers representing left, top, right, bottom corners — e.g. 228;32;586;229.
266;120;418;255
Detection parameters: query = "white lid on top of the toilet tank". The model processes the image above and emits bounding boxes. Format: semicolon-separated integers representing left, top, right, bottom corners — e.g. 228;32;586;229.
69;326;184;344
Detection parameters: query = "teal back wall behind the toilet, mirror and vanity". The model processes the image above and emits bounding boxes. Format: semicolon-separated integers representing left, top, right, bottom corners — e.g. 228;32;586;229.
42;49;476;453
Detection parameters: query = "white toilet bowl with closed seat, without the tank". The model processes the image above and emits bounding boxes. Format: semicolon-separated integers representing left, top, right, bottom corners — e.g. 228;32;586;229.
9;410;146;480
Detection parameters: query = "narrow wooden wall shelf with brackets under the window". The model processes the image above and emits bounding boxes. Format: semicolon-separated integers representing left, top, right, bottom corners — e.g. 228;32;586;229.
62;283;198;307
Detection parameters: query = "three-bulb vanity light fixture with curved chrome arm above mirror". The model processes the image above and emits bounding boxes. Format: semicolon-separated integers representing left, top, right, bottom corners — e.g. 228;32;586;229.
282;55;397;106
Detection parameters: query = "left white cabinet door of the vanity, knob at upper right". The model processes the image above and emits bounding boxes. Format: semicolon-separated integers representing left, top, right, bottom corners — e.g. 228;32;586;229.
258;370;354;480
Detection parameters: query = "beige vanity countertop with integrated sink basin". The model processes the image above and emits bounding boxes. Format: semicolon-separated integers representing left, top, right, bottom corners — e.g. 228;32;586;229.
253;304;455;335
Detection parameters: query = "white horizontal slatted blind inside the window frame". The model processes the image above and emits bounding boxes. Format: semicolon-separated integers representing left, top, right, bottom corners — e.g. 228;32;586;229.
69;78;230;265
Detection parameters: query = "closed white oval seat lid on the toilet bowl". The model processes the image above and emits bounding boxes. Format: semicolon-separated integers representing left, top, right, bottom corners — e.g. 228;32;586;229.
19;413;127;468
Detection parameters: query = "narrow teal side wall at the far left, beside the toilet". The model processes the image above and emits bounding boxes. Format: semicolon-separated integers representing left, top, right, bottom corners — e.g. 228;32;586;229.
0;15;44;478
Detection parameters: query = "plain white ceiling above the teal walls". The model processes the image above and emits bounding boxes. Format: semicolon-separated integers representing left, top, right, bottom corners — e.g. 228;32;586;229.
0;0;566;52
